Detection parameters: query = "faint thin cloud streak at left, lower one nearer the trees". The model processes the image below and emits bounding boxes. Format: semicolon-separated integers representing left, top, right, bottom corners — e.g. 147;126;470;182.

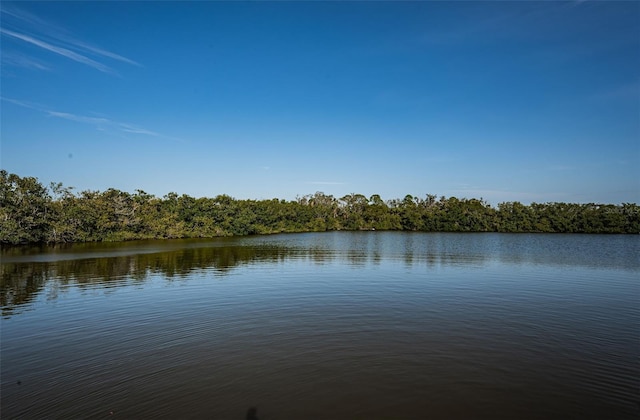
1;97;184;142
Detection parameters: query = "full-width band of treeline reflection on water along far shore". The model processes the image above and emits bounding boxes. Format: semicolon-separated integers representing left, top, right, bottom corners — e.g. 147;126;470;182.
0;232;640;316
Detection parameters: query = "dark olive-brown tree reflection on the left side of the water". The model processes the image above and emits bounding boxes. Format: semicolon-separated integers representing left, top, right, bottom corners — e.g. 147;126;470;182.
0;244;296;317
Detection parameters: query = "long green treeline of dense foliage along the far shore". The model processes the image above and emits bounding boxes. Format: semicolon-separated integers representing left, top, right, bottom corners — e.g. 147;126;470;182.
0;170;640;244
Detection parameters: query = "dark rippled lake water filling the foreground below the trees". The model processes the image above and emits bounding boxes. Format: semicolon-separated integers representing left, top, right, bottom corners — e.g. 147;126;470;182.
0;232;640;420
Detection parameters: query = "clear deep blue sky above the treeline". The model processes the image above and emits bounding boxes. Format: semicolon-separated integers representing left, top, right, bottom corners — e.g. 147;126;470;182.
0;1;640;205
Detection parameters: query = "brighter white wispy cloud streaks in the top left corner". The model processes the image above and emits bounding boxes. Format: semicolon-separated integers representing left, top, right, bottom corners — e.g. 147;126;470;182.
0;6;140;74
